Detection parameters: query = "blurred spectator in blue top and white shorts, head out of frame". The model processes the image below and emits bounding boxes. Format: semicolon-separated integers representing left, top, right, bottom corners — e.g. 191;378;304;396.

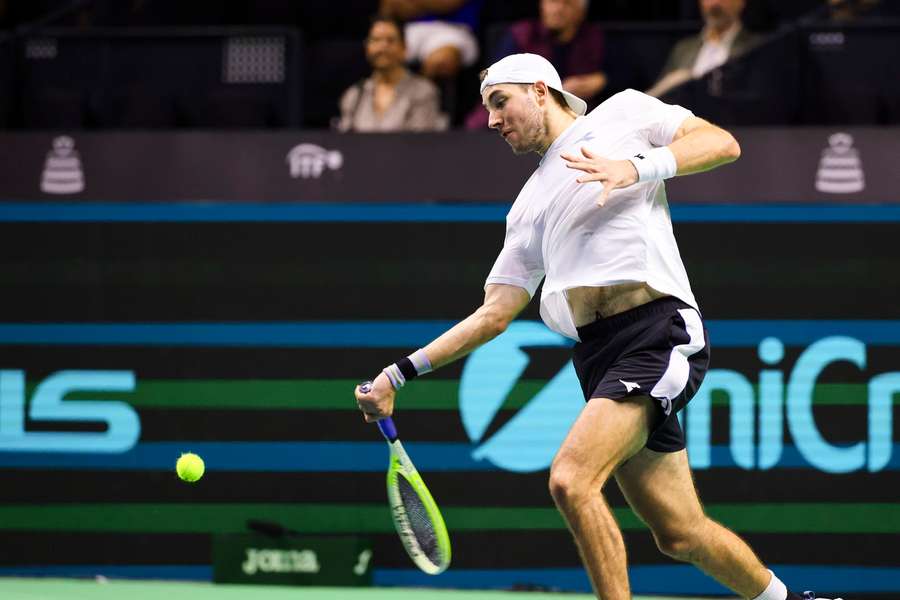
380;0;484;79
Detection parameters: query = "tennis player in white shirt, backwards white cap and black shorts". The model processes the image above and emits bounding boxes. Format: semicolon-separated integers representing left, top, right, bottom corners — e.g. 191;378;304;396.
356;54;840;600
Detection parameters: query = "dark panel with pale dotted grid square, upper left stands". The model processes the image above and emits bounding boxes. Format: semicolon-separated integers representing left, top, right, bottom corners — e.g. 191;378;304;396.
20;28;302;128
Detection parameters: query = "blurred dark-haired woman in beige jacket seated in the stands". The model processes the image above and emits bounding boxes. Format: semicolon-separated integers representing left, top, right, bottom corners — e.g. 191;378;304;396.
337;17;447;132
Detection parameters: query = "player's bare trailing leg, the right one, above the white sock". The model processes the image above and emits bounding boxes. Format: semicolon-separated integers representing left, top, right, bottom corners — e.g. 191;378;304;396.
615;448;771;598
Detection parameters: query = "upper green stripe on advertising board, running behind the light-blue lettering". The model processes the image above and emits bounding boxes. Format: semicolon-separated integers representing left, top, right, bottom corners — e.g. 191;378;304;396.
52;379;888;411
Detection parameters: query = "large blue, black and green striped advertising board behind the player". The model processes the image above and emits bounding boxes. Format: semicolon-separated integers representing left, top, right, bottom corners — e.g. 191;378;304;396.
0;200;900;598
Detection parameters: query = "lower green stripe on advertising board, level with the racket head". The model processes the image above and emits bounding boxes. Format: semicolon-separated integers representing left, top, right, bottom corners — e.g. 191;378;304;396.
0;504;900;533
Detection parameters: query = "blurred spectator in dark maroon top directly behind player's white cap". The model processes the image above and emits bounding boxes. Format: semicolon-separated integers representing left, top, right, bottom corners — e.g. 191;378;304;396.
466;0;606;129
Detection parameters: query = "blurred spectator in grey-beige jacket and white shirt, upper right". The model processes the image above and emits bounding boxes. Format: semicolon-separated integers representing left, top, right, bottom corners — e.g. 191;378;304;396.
647;0;761;96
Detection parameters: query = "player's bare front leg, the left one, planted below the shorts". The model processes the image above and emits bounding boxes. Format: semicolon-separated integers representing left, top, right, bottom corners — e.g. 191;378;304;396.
550;398;656;600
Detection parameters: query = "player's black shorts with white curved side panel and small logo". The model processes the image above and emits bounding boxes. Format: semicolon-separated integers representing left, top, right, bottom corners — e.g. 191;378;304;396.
573;296;709;452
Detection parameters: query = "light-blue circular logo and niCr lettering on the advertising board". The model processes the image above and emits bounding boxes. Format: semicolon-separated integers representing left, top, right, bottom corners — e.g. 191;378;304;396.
459;321;900;473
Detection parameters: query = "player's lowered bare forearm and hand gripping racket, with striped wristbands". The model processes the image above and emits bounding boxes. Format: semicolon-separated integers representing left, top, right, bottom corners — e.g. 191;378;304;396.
356;284;531;423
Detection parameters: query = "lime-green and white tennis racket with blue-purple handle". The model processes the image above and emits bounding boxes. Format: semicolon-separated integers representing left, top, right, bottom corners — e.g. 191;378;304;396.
359;381;450;575
